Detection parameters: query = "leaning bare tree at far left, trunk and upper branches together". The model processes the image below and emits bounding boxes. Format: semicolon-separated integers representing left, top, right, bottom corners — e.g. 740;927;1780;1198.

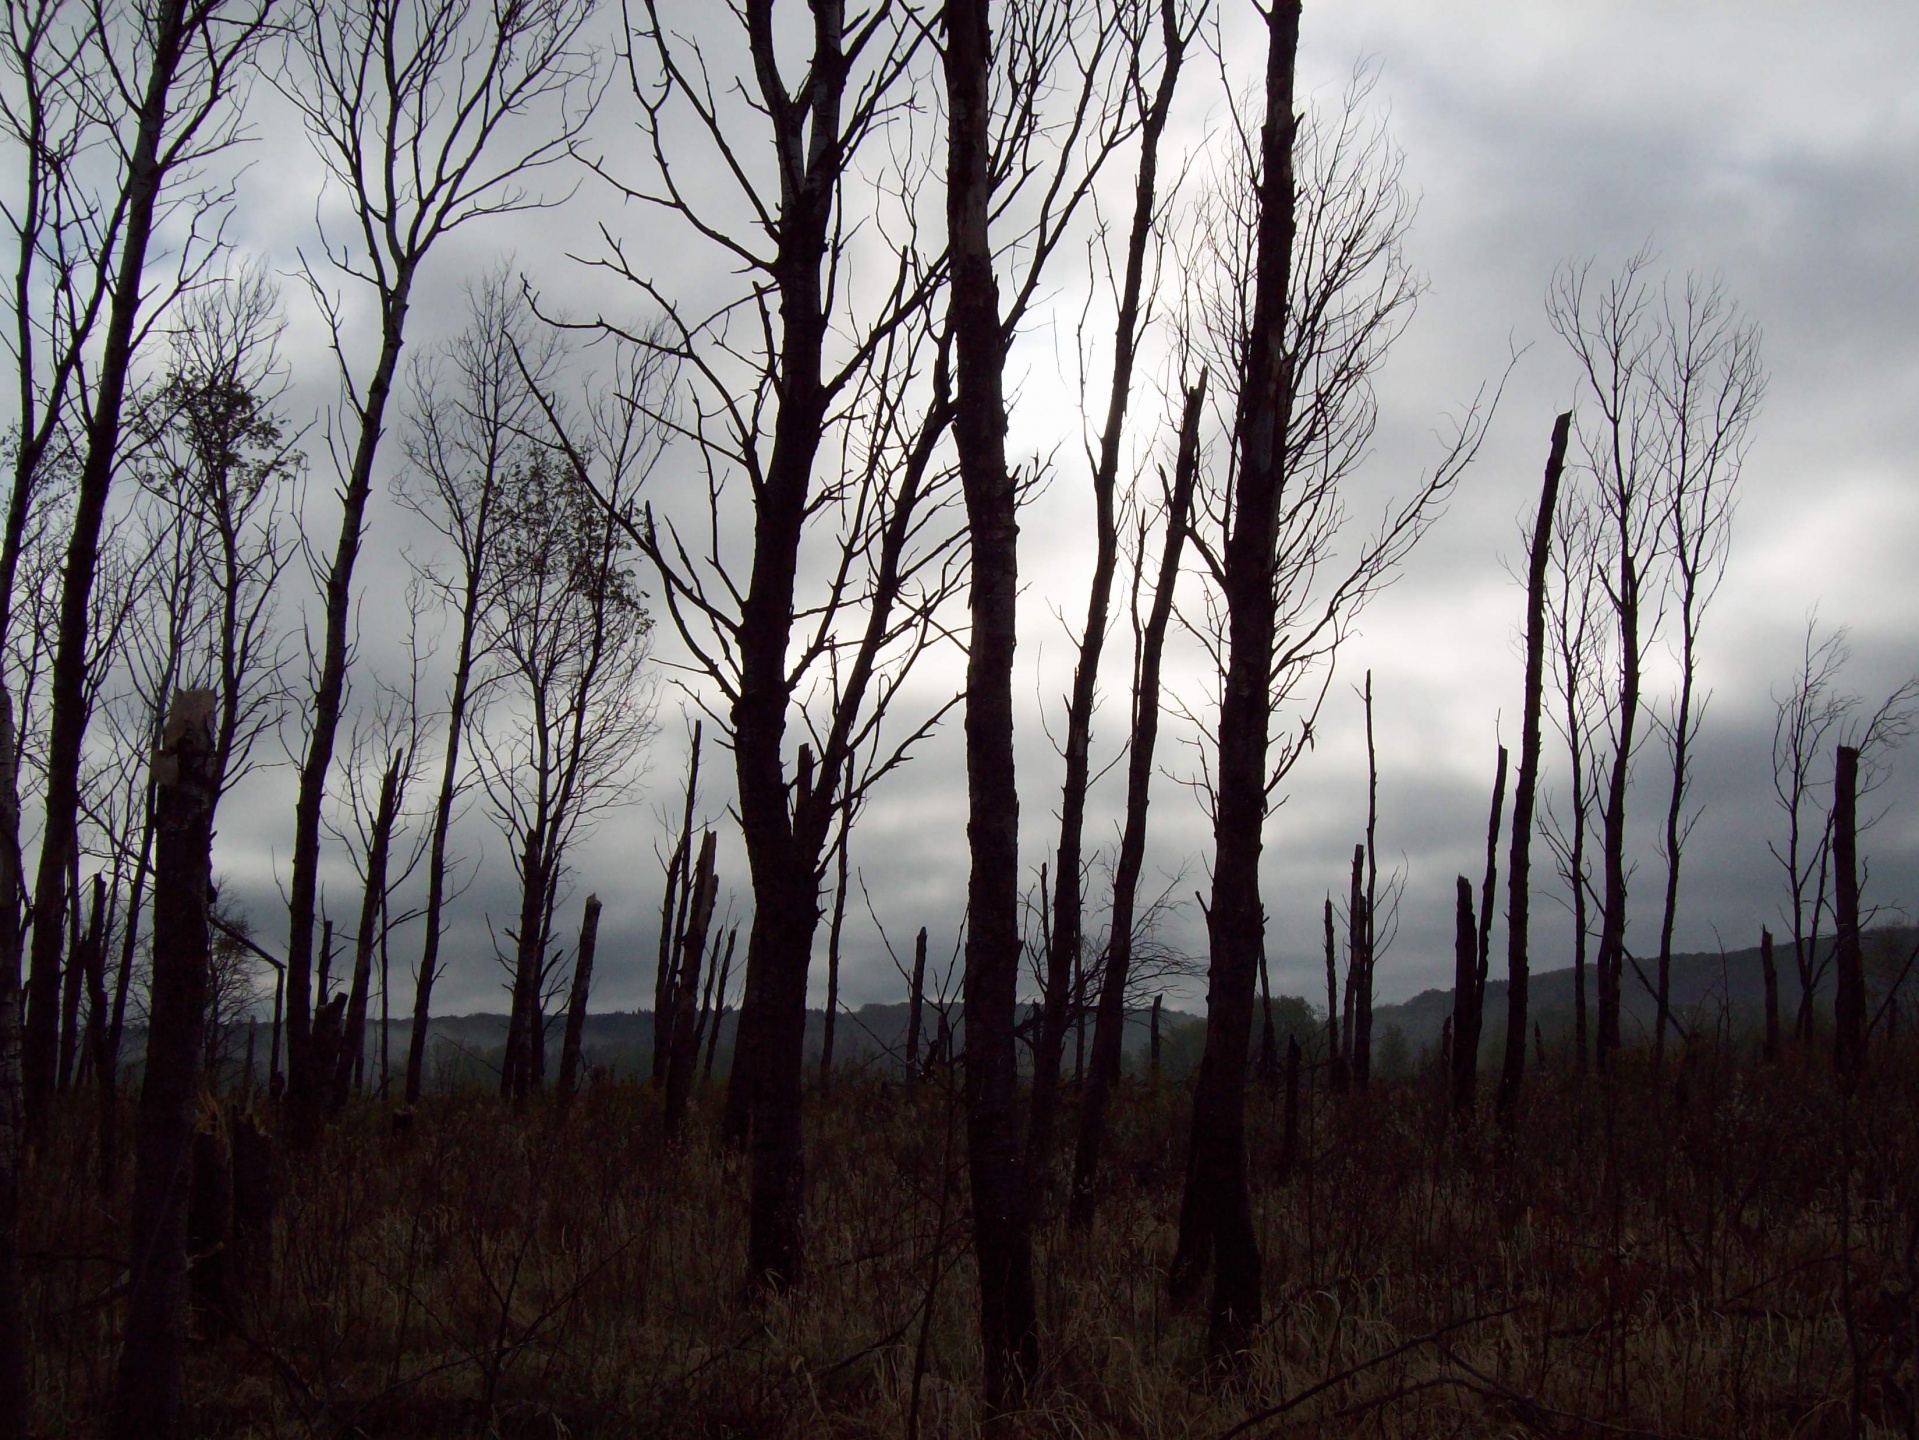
23;0;267;1125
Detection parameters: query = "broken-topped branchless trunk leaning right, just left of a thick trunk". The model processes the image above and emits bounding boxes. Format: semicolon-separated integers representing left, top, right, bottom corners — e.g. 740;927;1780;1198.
1069;371;1207;1229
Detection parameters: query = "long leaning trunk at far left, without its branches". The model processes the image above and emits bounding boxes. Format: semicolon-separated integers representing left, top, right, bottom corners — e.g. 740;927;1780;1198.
21;0;203;1129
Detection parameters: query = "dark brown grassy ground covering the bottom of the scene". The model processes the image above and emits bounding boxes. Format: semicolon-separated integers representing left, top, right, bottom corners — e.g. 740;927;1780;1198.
21;1050;1919;1440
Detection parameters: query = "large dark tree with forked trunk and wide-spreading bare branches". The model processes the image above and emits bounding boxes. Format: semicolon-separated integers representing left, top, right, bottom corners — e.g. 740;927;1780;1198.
595;0;982;1286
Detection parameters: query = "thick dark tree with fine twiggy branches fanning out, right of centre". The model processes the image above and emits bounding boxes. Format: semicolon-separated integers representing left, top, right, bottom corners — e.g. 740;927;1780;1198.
1171;42;1483;1361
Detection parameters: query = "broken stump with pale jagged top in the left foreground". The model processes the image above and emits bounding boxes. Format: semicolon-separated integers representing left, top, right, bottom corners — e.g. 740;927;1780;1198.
109;689;219;1440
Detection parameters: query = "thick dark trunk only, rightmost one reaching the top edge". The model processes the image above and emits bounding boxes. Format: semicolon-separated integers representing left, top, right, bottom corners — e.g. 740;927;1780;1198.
1173;0;1299;1361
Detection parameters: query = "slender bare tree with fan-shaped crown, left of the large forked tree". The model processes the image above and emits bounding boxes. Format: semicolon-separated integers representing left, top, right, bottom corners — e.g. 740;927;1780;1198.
280;0;595;1140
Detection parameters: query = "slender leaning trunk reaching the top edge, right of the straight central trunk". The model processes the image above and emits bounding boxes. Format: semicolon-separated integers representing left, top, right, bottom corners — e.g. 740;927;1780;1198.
1027;0;1186;1187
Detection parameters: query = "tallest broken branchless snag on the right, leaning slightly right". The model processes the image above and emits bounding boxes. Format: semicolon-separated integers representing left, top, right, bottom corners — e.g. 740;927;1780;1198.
1499;411;1572;1135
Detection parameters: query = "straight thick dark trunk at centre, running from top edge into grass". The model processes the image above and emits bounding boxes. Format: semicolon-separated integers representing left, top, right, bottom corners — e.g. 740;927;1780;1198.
942;0;1036;1413
